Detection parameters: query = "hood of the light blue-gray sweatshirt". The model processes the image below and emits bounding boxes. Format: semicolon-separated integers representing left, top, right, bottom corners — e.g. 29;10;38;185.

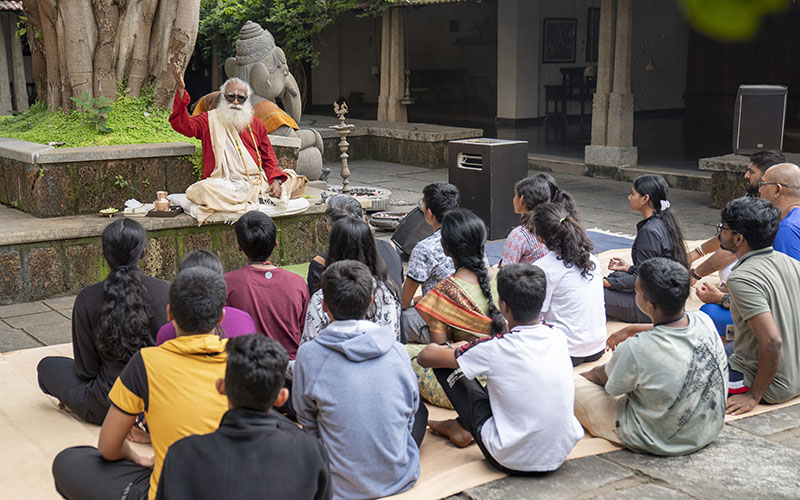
316;319;395;362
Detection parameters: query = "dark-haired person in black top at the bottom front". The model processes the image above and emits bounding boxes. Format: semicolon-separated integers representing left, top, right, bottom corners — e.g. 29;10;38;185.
156;335;331;500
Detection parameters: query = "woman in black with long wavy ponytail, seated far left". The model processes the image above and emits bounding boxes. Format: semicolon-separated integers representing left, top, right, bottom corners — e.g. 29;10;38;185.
37;218;169;425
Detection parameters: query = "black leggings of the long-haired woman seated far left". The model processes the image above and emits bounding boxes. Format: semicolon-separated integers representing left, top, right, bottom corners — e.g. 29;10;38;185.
36;356;108;425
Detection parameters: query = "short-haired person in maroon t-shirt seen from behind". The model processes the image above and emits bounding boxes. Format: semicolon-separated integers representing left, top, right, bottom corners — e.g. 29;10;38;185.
225;212;309;359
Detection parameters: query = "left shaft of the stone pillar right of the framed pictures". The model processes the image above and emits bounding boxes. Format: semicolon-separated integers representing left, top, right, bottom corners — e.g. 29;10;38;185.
592;0;616;146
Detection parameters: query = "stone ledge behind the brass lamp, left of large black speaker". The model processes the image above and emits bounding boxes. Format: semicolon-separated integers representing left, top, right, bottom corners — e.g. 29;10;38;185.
300;115;483;168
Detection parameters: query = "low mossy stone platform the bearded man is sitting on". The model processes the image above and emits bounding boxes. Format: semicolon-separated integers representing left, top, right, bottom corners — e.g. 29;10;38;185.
0;199;328;305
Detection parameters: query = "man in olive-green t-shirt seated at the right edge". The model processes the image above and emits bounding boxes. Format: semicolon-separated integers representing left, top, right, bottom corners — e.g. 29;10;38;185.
717;198;800;415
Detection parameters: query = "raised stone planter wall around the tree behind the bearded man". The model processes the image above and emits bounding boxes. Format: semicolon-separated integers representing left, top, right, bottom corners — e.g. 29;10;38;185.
0;136;300;217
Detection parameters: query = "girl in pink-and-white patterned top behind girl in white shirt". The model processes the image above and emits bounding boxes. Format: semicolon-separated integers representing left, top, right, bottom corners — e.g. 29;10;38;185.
499;172;578;266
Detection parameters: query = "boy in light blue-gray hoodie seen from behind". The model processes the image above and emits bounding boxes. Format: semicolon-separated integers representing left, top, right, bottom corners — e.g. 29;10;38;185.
292;260;428;498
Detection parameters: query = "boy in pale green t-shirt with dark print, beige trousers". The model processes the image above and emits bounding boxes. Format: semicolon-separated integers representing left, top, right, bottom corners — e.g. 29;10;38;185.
575;257;728;455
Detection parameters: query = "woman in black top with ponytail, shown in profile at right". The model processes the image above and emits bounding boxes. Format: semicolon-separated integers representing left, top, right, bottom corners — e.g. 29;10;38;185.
603;174;689;323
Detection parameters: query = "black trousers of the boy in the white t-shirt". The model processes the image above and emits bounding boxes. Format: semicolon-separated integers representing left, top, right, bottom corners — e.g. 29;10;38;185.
433;368;547;476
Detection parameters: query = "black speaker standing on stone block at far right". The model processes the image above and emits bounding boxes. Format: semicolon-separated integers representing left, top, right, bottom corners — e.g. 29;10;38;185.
733;85;787;155
